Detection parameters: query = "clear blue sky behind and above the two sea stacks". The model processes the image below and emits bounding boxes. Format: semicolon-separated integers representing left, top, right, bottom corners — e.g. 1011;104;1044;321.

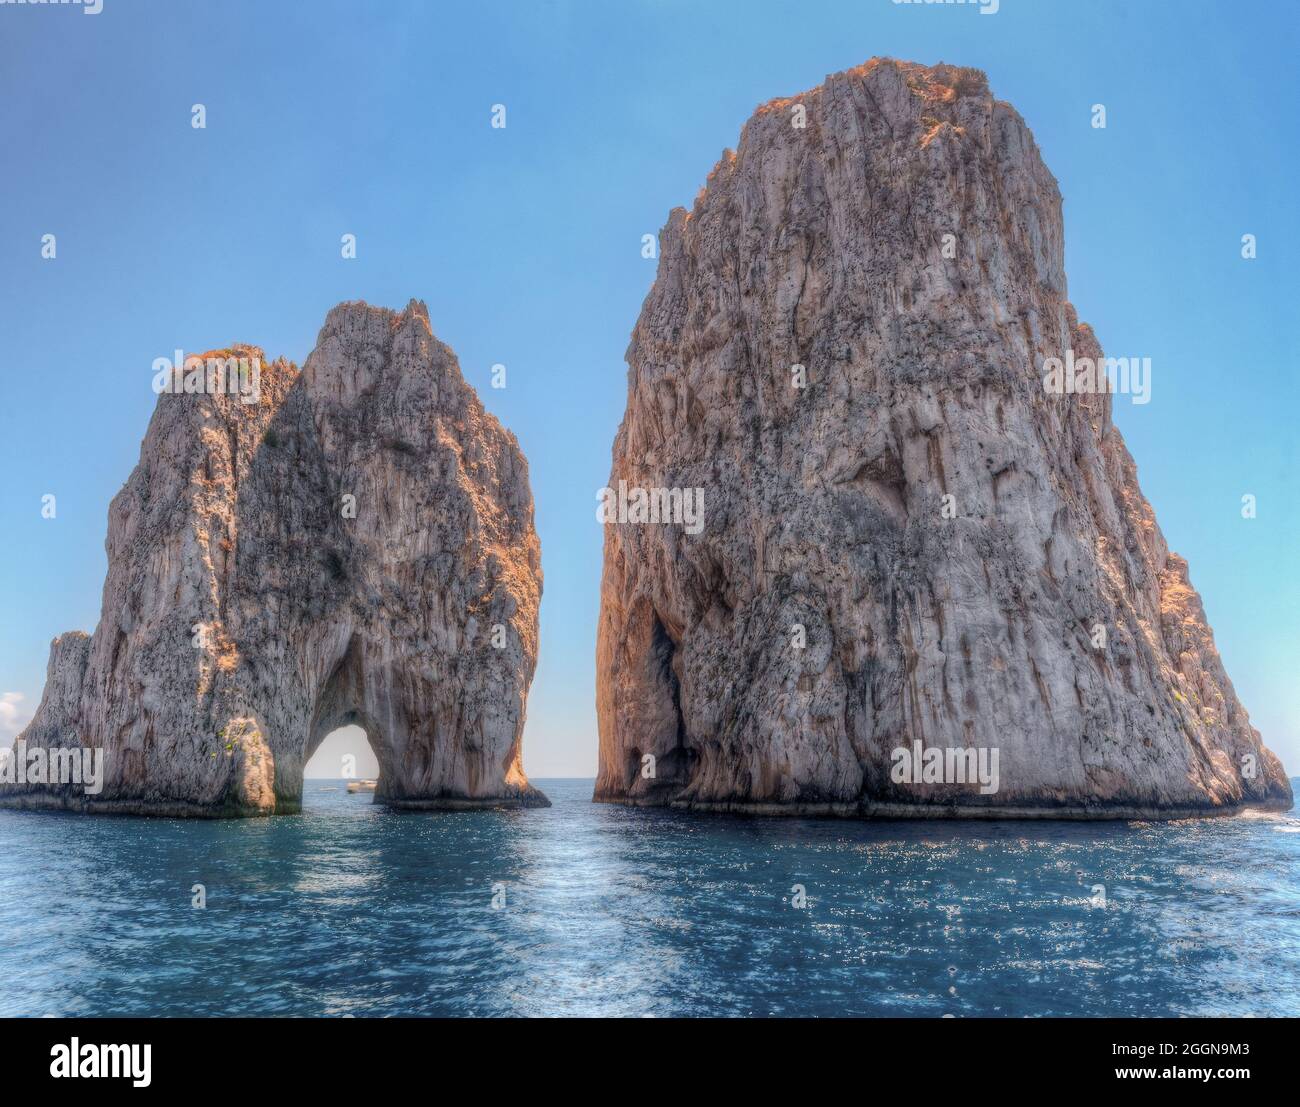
0;0;1300;777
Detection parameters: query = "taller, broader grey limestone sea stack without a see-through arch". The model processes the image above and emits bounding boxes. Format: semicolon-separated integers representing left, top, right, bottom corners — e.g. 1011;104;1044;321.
595;58;1291;817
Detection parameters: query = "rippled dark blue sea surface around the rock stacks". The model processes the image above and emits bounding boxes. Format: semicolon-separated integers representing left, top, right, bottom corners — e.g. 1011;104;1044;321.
0;780;1300;1016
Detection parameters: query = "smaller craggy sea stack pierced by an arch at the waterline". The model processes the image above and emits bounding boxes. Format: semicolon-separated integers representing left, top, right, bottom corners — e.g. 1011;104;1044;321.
3;301;546;815
